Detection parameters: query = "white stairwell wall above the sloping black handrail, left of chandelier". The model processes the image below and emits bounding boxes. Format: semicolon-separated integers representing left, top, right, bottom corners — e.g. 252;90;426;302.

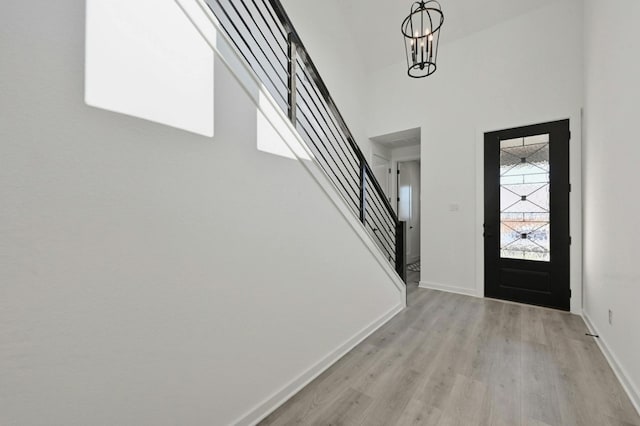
282;0;372;160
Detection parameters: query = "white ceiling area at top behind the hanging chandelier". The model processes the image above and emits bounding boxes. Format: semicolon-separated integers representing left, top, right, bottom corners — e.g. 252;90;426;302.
337;0;564;70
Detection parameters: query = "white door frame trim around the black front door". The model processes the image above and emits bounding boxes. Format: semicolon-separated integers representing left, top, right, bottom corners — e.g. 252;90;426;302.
475;109;583;315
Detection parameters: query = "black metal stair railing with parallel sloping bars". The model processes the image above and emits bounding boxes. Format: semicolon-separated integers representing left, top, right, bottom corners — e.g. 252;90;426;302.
206;0;406;281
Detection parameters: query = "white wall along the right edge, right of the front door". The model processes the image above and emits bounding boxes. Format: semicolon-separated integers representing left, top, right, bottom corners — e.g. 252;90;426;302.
584;0;640;410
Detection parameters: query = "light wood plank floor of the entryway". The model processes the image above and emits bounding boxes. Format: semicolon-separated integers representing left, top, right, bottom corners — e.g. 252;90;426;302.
261;283;640;426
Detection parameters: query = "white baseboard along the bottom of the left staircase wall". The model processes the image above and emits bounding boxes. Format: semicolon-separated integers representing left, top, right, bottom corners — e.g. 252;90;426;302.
232;304;404;425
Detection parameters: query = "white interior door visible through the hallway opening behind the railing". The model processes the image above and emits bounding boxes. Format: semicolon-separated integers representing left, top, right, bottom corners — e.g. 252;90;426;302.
398;160;420;263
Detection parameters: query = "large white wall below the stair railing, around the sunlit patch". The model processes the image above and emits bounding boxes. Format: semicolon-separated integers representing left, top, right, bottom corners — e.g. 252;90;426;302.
0;0;402;425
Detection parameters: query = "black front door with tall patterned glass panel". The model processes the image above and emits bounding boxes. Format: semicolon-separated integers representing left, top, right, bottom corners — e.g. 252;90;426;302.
484;120;571;311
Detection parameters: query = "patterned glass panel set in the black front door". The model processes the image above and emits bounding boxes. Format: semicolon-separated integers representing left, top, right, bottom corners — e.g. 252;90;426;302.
500;134;551;262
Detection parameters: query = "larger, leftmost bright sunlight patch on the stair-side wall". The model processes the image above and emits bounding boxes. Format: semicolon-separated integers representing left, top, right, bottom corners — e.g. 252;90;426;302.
85;0;214;136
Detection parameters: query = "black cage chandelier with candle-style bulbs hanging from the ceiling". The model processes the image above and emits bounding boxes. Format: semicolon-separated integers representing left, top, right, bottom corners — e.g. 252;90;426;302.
402;0;444;78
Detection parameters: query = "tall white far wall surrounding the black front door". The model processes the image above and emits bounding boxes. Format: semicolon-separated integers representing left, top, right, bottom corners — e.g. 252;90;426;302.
367;0;583;312
